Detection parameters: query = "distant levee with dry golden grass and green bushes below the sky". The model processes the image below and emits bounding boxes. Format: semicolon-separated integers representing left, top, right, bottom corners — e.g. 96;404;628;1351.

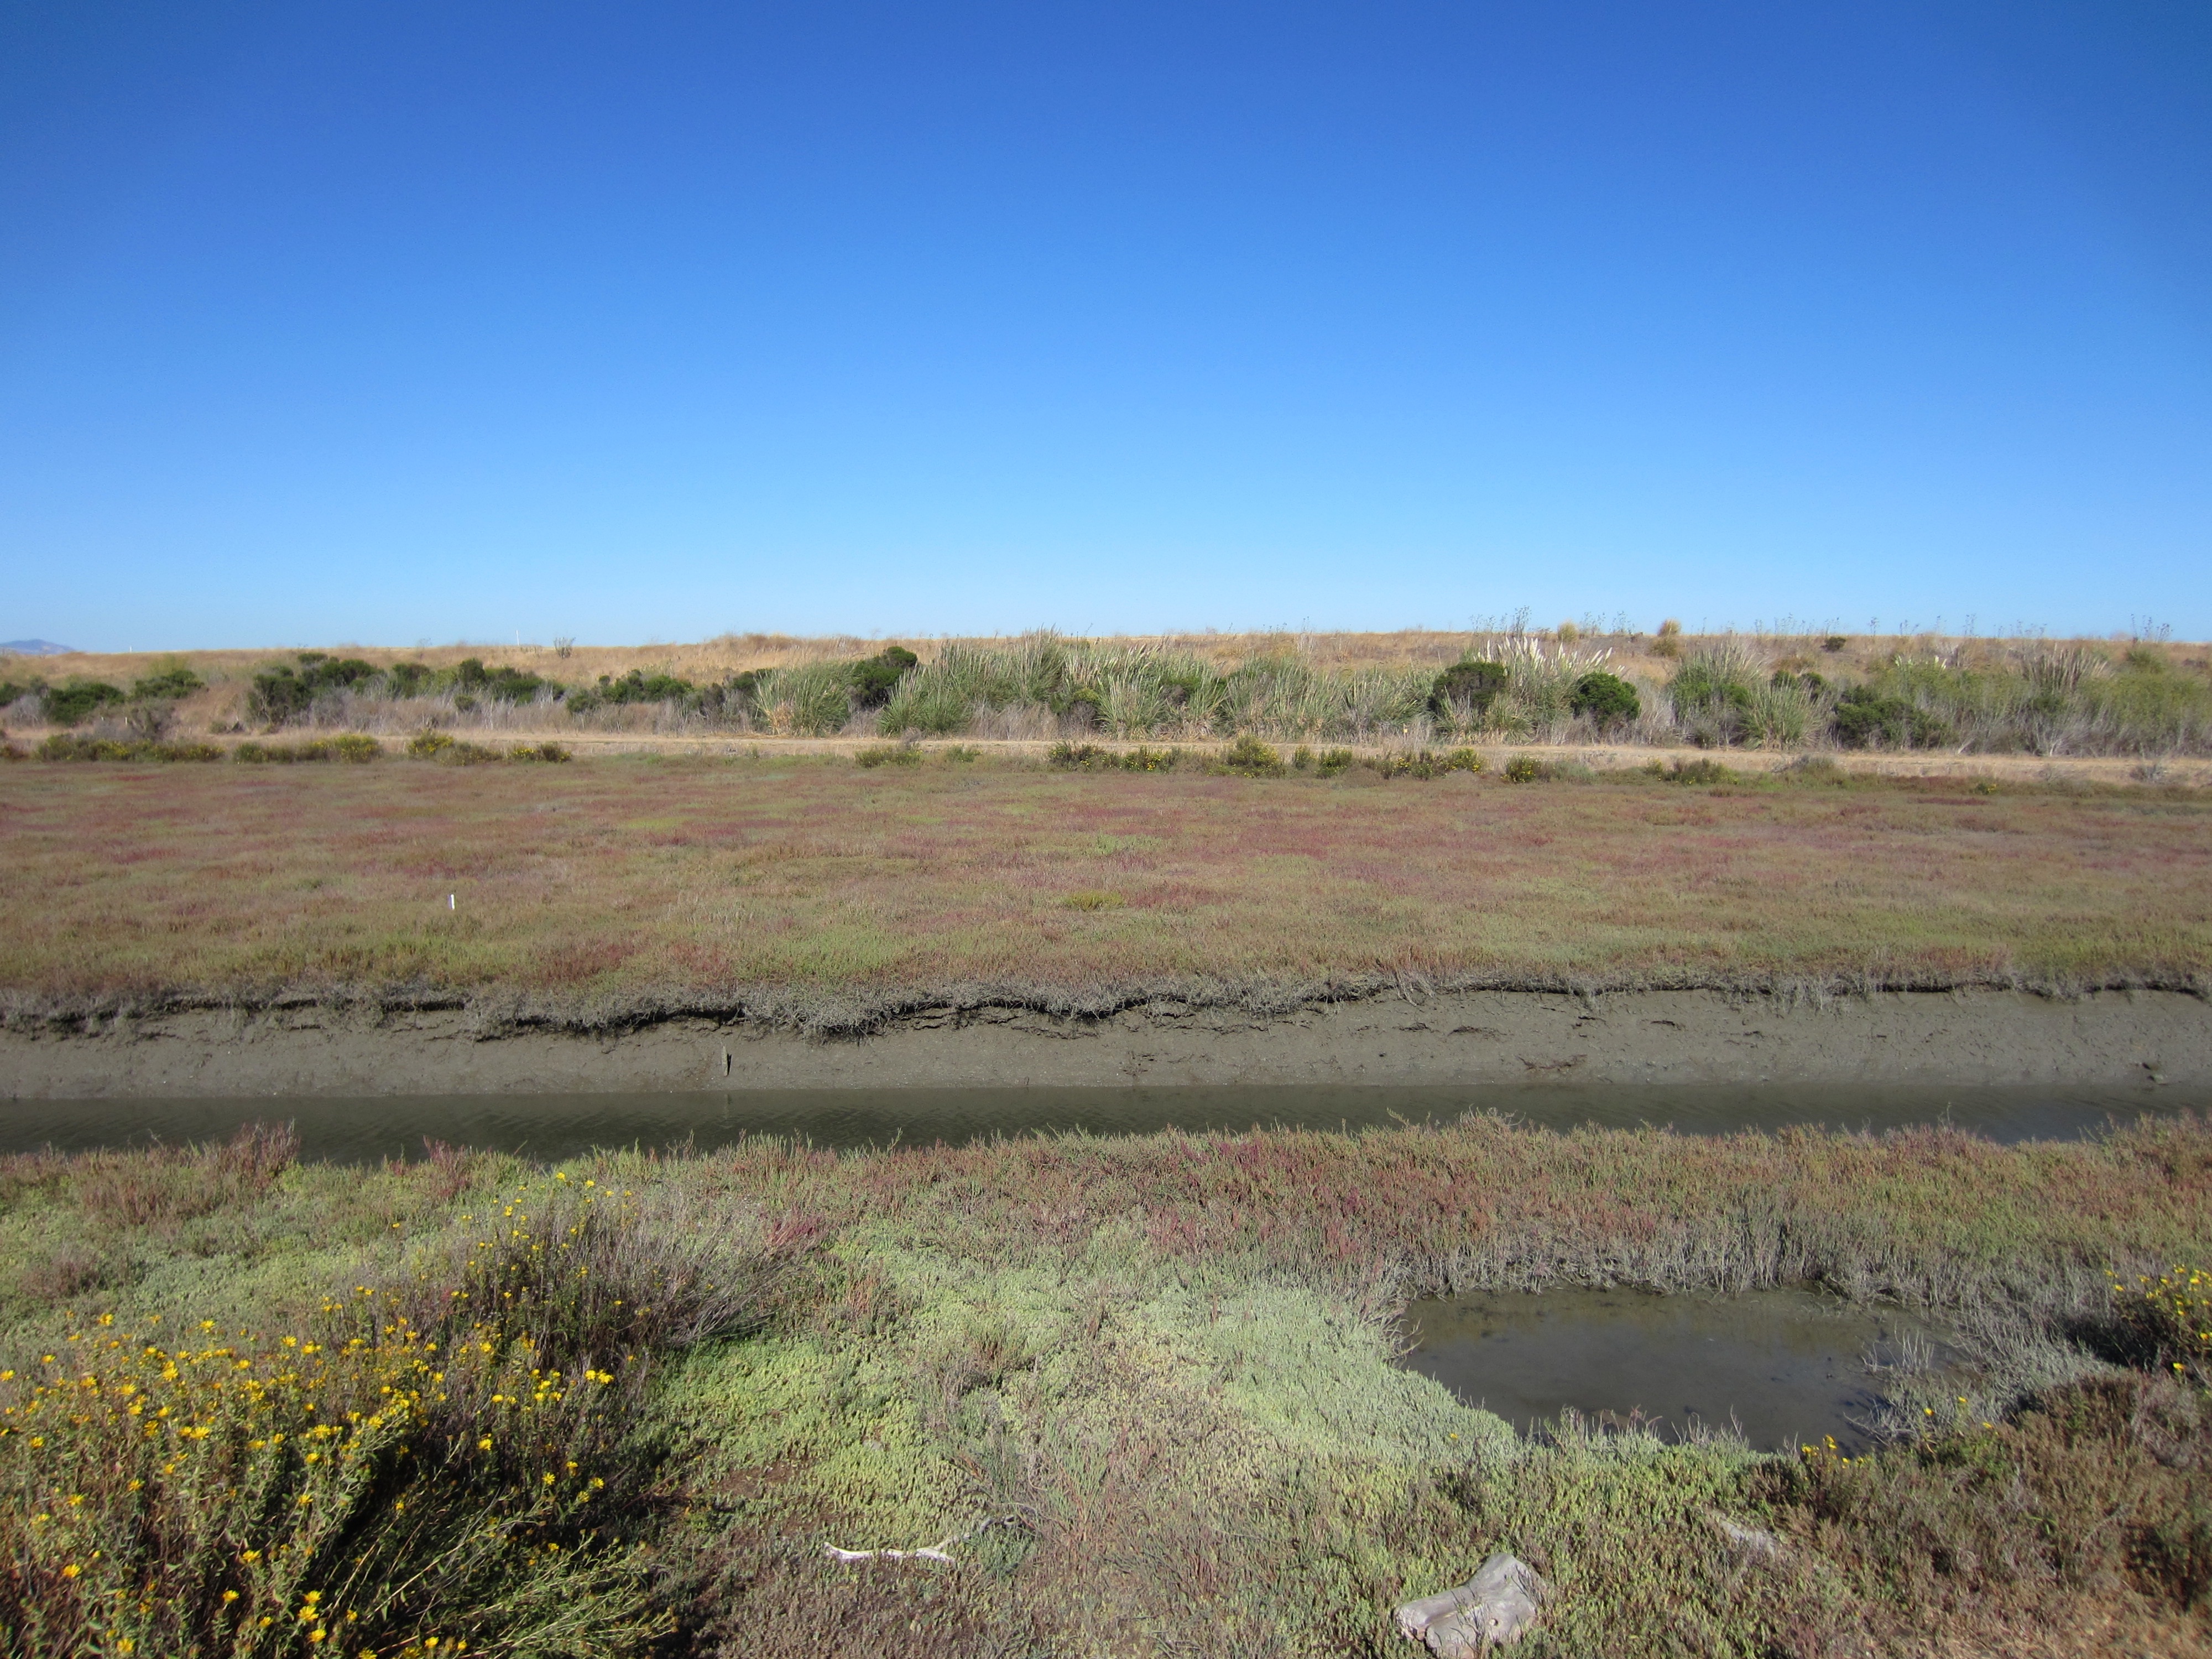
13;619;2212;768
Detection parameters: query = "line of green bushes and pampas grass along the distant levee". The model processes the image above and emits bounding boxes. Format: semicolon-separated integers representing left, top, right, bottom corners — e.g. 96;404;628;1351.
22;630;2212;757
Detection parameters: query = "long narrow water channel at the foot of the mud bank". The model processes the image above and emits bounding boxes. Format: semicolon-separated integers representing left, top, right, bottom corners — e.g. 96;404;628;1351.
0;1084;2185;1164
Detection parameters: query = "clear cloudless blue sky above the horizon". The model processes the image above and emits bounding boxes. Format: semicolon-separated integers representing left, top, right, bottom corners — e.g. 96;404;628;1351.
0;0;2212;648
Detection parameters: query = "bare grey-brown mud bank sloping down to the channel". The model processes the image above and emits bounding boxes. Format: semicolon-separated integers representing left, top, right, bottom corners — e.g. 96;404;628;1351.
0;991;2212;1099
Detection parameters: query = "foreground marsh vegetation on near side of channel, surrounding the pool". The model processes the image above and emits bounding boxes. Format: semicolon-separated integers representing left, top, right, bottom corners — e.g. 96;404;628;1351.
0;1117;2212;1659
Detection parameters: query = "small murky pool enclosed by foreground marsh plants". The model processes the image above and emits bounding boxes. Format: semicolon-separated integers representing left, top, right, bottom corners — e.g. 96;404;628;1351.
1405;1290;1924;1451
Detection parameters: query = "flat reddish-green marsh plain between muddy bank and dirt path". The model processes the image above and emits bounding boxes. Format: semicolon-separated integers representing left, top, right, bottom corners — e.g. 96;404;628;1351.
0;757;2212;1018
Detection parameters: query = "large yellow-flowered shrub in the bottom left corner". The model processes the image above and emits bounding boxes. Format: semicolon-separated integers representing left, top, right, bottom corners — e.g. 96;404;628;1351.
0;1177;774;1659
